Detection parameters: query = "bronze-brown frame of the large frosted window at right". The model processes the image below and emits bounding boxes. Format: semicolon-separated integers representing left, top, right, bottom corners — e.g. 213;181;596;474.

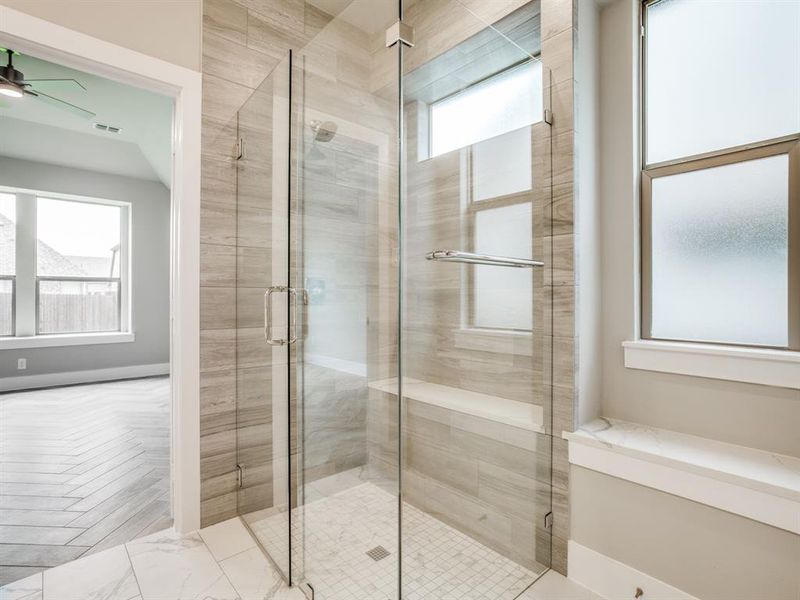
639;0;800;351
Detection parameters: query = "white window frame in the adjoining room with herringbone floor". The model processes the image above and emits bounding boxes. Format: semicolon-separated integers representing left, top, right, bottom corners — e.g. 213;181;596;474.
0;186;133;340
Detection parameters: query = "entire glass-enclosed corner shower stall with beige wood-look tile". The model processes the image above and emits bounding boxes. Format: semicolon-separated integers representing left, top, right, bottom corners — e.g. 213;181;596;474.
235;0;553;600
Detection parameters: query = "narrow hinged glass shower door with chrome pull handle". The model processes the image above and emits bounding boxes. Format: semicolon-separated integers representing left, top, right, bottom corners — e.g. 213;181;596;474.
236;54;298;581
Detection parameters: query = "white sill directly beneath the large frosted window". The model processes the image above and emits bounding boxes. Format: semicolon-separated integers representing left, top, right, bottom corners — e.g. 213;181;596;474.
622;340;800;389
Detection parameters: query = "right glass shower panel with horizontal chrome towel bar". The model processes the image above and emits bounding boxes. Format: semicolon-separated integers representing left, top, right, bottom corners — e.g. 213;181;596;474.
400;0;551;600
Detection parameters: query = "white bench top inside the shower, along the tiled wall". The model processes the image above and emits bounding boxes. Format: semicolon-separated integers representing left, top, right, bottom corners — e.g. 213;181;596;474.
369;377;544;433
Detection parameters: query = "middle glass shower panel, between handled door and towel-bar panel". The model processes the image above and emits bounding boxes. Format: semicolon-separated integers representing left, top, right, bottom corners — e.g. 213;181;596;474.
291;0;399;600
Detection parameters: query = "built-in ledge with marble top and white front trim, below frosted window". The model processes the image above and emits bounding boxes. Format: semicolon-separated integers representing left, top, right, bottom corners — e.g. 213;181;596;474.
563;418;800;534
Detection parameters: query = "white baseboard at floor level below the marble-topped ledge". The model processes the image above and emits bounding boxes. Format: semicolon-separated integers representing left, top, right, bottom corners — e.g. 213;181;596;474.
567;540;698;600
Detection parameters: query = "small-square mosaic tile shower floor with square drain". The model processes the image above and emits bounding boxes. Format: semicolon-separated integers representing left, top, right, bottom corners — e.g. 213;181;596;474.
247;482;540;600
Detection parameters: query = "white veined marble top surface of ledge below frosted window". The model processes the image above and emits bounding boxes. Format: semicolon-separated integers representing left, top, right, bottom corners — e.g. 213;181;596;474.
563;418;800;501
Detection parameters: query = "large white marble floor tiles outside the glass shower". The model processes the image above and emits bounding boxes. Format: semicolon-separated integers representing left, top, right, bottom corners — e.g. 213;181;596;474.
0;518;602;600
